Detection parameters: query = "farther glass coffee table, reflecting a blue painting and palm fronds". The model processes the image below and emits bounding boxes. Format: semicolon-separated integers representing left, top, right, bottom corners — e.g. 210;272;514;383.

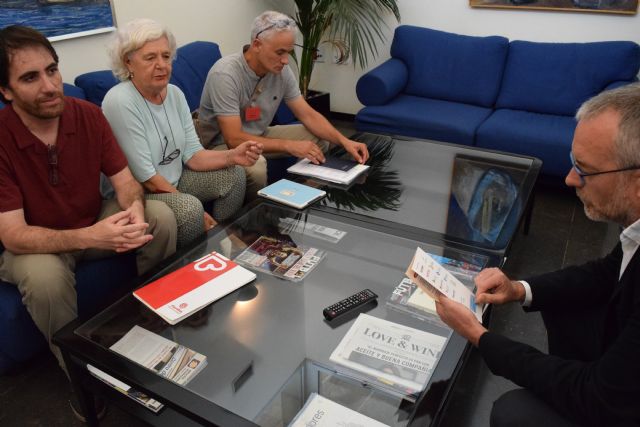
290;133;542;257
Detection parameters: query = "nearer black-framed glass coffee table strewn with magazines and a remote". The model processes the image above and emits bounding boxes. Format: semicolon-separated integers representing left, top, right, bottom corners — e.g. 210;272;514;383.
54;202;502;426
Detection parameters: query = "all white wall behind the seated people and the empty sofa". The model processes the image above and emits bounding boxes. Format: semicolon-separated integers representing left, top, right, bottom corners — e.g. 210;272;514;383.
10;0;640;114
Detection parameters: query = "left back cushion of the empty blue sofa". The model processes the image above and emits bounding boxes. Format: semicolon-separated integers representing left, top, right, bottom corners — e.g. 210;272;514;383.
391;25;509;107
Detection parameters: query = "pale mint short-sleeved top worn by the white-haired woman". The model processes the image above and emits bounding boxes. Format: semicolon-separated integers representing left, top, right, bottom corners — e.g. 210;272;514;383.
102;81;204;186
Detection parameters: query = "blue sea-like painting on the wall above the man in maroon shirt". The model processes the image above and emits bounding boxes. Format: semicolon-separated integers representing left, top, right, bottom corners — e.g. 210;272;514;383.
0;0;115;41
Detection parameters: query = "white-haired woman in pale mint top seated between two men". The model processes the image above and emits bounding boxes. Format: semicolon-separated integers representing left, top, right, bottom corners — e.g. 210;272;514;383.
102;19;262;246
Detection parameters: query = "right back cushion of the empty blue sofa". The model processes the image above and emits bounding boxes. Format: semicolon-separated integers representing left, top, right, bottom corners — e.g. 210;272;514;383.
496;41;640;116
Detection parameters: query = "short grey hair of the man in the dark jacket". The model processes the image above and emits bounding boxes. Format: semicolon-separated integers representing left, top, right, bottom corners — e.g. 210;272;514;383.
576;83;640;168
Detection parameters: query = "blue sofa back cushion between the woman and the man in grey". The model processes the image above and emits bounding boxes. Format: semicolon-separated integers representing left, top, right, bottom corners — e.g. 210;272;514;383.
171;41;222;111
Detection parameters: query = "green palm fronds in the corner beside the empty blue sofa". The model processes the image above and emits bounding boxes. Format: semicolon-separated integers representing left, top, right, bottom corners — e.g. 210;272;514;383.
282;0;400;98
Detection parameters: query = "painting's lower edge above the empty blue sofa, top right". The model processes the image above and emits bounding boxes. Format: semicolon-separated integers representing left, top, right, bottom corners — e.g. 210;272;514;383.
469;0;638;15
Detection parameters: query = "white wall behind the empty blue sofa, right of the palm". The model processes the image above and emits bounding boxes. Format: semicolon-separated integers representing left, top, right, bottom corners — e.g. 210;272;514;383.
311;0;640;114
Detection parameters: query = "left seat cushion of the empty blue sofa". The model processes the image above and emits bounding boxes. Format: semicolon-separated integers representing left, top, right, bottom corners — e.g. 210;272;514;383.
356;95;491;145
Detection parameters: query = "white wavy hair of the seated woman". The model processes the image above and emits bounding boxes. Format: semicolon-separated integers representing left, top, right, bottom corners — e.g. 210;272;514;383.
108;18;176;81
